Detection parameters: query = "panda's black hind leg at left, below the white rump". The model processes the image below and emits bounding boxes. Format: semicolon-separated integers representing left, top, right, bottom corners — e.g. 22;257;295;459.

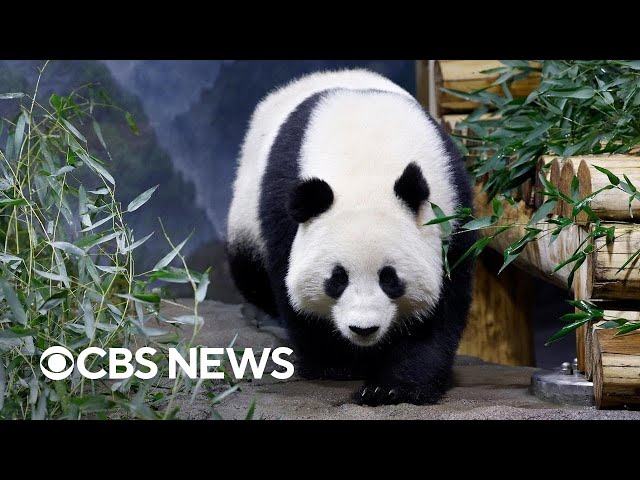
227;242;278;317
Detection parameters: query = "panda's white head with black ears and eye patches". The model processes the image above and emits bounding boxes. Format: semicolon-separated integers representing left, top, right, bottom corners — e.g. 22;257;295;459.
286;163;443;347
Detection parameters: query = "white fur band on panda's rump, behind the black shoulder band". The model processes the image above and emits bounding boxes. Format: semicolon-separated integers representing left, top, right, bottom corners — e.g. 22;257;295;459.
227;70;412;256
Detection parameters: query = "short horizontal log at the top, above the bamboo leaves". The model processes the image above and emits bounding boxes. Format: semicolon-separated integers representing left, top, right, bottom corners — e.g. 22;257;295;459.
434;60;540;116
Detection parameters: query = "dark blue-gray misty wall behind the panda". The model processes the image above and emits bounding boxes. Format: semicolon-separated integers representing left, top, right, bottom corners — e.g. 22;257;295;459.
0;60;573;366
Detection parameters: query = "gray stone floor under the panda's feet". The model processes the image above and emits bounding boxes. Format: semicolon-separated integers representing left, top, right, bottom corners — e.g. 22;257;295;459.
163;300;640;420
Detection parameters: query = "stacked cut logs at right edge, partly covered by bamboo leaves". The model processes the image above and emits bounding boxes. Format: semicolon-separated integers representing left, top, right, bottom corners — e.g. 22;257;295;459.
476;156;640;408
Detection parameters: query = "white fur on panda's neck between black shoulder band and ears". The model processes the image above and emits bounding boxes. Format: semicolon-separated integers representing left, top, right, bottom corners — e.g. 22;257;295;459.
300;91;456;224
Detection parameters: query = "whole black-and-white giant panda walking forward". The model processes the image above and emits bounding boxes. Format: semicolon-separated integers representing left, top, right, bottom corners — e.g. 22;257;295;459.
227;70;473;405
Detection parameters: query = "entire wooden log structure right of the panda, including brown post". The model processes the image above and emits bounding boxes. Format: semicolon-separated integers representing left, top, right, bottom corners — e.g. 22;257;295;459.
417;60;640;408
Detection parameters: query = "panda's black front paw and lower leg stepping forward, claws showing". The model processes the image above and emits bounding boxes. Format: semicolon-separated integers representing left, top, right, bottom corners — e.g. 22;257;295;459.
356;336;457;406
